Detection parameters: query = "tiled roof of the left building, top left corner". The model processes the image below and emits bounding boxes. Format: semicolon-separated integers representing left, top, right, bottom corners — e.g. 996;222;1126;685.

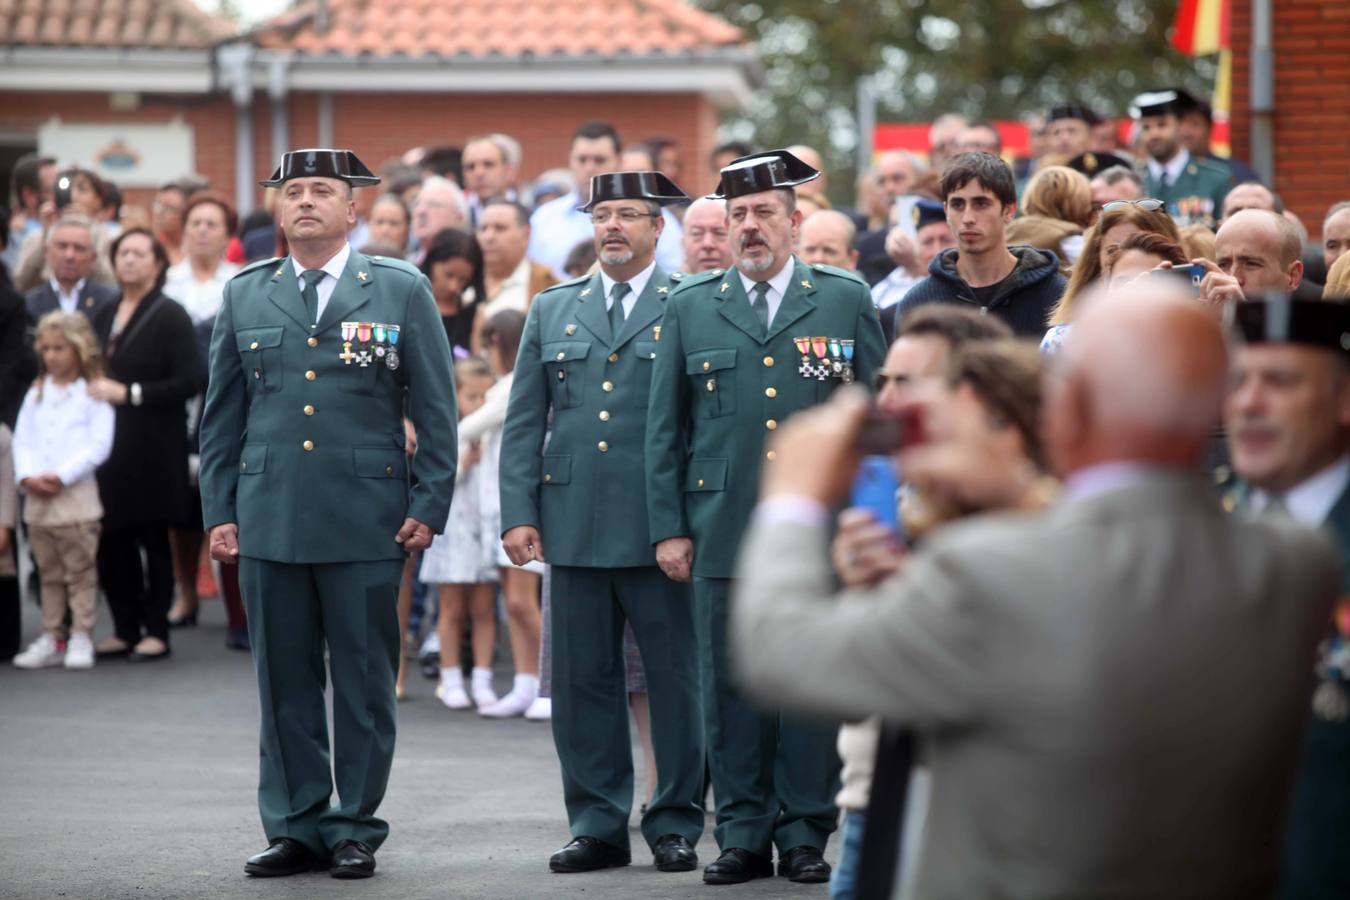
0;0;235;50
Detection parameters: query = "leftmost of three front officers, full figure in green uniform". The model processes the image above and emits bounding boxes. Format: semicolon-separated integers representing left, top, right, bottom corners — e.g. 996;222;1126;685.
200;150;458;878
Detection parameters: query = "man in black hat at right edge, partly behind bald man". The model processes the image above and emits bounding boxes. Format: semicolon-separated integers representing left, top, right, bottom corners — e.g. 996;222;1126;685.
1224;300;1350;900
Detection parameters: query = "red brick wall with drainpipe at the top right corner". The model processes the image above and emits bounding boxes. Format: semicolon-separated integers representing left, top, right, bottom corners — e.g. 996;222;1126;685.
1231;0;1350;239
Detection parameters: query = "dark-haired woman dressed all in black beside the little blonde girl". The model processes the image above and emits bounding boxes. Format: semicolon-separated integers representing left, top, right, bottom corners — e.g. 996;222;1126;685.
89;228;201;661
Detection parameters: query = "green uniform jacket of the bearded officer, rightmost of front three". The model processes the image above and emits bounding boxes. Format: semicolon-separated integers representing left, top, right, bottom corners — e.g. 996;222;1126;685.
647;259;886;578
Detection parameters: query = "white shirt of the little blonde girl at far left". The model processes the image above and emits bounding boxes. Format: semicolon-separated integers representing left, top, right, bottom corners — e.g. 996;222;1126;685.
14;375;113;486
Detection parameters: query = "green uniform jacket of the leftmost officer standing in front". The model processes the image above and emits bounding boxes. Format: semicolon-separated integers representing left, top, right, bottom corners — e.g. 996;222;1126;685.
200;251;458;563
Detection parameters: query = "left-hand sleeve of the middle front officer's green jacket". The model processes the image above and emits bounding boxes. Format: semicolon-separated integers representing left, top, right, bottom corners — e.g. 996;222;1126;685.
497;297;548;534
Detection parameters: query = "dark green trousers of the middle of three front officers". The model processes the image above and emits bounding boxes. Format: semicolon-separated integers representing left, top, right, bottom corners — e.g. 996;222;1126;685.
551;565;703;850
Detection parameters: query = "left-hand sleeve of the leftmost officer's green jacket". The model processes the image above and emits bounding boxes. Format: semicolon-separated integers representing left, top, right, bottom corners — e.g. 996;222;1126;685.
197;282;248;530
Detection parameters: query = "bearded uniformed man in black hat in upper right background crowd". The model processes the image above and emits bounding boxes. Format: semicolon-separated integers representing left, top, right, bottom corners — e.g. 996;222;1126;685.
1133;90;1233;228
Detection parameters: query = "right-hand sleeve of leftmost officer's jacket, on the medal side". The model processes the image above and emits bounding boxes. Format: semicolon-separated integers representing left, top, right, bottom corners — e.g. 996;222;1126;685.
404;275;459;533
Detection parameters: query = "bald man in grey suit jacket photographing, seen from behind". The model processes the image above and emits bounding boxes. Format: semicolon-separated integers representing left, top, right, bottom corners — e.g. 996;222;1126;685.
734;287;1338;900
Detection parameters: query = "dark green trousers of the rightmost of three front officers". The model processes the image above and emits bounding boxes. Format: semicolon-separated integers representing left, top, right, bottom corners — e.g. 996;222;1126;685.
694;578;840;860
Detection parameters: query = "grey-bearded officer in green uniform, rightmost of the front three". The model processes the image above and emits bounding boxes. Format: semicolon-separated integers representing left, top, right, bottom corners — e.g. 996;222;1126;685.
647;150;886;884
